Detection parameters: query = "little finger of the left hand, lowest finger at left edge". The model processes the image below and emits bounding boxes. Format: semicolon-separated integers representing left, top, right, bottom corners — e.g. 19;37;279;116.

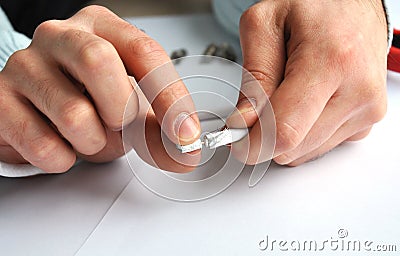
0;88;76;173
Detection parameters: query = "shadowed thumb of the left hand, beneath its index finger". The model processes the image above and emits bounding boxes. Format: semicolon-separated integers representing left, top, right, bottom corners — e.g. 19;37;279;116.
77;78;201;167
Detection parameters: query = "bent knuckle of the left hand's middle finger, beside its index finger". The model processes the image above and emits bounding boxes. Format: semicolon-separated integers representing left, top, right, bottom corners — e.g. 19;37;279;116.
79;40;116;73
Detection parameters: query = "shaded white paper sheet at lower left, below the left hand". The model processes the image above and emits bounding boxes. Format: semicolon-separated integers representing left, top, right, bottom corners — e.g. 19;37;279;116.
0;159;132;256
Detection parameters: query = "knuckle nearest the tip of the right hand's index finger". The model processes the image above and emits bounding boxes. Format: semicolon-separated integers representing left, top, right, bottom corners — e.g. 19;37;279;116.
276;123;302;152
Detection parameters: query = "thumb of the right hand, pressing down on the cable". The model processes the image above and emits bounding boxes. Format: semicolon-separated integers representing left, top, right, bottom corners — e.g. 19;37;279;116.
229;2;286;126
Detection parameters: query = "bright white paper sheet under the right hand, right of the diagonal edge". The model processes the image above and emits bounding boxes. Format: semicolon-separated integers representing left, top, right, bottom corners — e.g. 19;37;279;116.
78;16;400;256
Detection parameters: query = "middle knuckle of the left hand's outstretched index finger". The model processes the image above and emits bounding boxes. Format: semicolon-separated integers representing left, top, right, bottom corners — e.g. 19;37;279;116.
128;36;165;58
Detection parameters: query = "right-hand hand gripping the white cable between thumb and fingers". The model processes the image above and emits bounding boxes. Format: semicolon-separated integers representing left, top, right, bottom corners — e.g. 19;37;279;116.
229;0;387;166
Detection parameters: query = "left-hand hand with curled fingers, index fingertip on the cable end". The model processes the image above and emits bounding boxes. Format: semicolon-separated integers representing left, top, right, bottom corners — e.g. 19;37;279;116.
0;6;200;172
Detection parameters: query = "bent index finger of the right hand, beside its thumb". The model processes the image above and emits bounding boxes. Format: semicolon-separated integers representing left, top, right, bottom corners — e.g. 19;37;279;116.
270;38;343;156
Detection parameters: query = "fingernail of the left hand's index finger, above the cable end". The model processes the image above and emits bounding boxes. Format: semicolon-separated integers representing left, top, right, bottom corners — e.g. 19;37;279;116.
174;113;200;143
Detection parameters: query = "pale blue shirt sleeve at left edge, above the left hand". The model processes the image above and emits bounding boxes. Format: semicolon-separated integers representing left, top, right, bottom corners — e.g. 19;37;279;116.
0;7;31;71
